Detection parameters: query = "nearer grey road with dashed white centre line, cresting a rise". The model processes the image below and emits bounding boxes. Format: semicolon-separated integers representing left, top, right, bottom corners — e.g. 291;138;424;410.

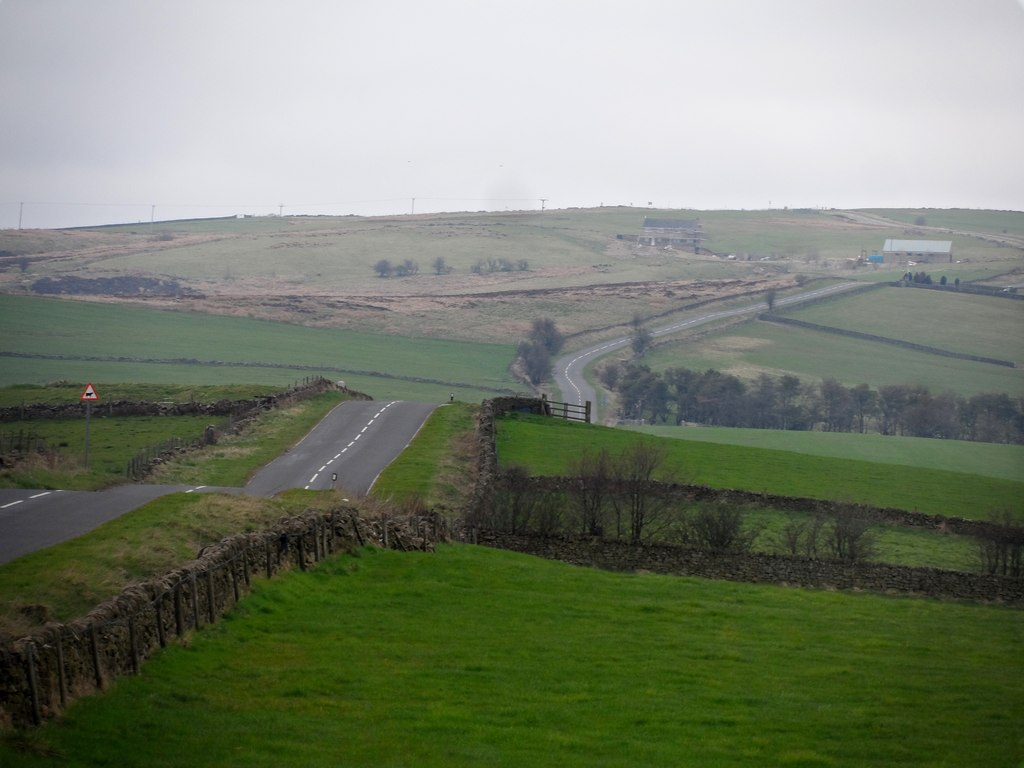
0;400;436;563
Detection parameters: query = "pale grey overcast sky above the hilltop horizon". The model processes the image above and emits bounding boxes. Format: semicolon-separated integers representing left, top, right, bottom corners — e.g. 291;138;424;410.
0;0;1024;228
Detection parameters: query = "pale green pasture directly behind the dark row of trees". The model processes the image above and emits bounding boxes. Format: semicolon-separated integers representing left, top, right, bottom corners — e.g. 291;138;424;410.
643;322;1024;397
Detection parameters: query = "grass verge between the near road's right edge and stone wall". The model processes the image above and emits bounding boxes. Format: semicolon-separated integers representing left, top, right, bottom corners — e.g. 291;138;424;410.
372;402;479;508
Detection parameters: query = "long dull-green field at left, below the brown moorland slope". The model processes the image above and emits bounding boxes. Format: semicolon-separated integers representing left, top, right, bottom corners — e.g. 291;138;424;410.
0;296;518;400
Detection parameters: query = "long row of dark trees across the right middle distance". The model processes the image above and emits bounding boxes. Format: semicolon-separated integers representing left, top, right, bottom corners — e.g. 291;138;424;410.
599;360;1024;443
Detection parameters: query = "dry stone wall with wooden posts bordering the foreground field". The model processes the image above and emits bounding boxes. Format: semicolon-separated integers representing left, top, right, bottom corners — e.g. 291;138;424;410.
0;509;450;730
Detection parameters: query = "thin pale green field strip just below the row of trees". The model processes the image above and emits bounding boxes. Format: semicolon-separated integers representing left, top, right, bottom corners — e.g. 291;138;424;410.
626;426;1024;480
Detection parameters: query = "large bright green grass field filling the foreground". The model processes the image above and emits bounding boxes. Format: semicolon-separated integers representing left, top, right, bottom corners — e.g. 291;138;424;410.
0;546;1024;768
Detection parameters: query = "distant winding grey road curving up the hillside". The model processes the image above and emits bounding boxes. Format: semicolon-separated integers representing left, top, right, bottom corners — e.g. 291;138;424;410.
552;283;863;422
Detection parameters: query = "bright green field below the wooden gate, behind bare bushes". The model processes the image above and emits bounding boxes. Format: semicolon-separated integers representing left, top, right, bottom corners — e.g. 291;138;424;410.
497;416;1024;519
